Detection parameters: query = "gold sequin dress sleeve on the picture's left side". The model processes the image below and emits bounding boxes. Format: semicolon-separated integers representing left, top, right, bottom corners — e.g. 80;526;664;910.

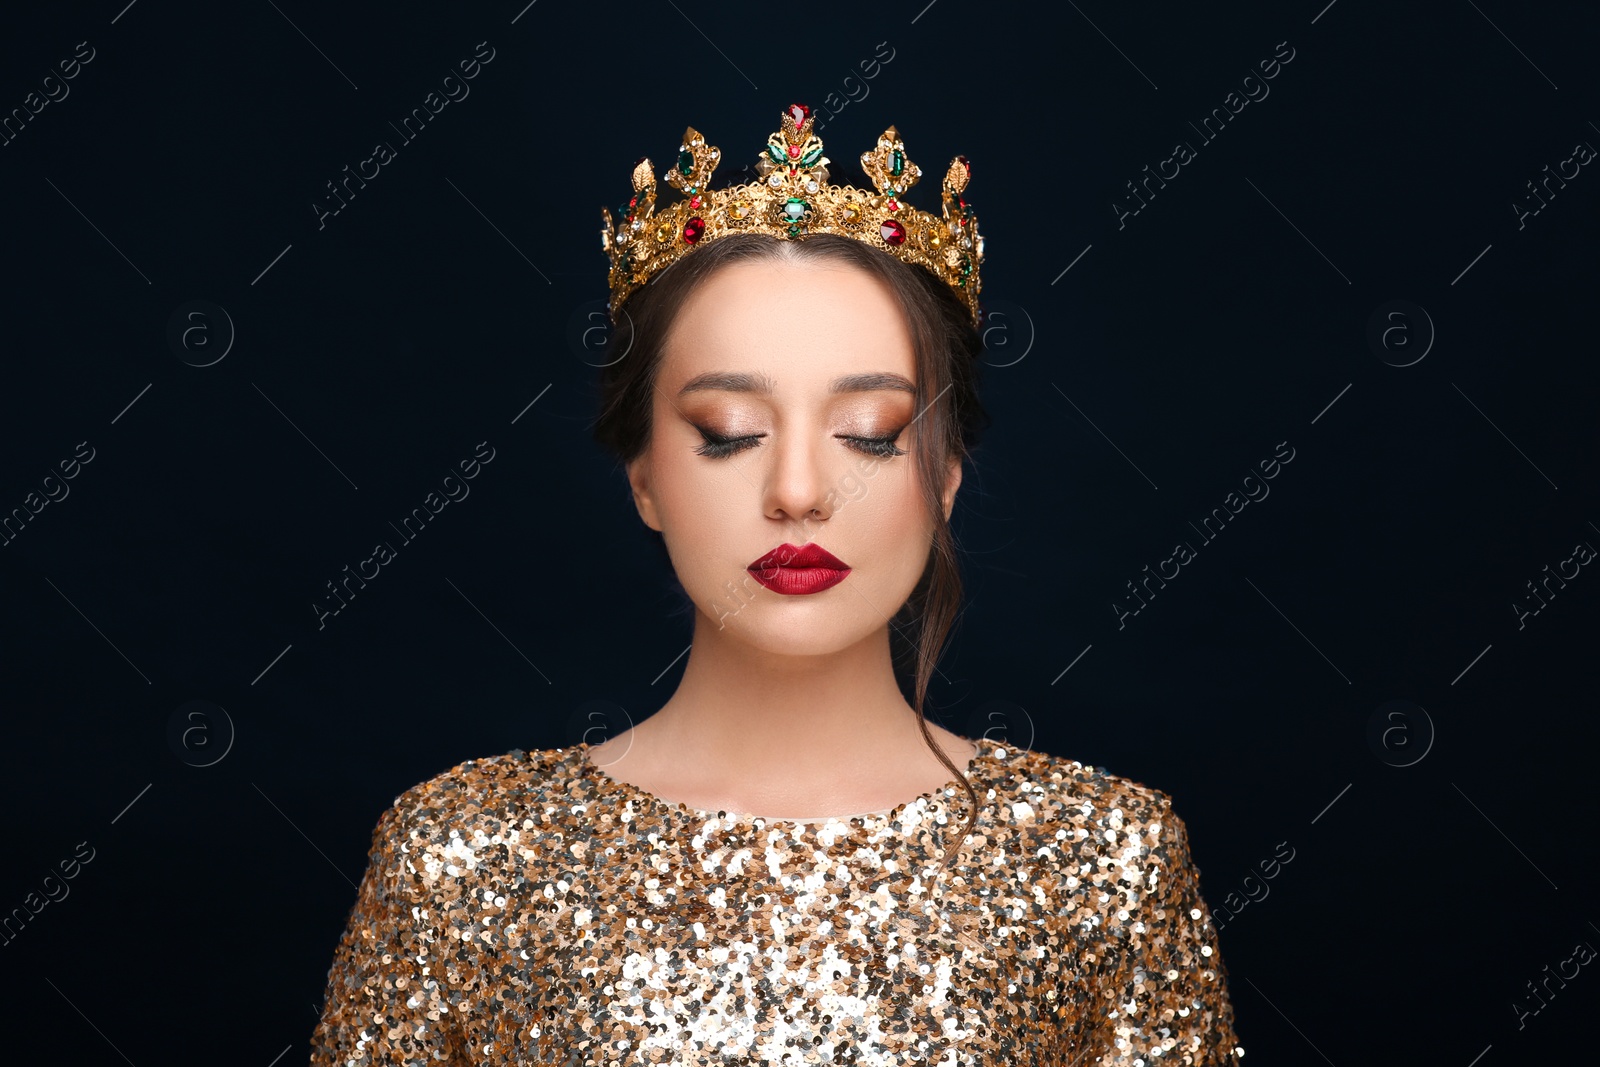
310;801;466;1067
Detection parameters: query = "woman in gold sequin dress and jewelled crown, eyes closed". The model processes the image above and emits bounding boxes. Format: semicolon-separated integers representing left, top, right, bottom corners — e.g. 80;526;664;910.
312;106;1243;1067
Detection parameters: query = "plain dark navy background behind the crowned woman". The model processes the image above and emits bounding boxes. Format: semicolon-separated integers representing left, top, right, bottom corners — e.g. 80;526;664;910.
0;0;1600;1067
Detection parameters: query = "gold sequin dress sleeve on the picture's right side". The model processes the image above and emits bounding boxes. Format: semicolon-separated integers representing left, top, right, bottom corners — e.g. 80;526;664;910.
1083;790;1245;1067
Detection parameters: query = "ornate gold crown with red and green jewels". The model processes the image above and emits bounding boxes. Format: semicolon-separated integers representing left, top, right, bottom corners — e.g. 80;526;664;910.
600;104;984;323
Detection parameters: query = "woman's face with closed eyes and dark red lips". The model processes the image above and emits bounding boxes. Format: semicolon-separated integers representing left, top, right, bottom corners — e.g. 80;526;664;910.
629;261;962;656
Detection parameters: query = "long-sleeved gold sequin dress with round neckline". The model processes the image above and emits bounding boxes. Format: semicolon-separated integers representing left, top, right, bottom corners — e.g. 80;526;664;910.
310;741;1243;1067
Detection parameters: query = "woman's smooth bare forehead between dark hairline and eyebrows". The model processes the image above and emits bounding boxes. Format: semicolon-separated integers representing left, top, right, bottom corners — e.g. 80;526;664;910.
659;261;917;392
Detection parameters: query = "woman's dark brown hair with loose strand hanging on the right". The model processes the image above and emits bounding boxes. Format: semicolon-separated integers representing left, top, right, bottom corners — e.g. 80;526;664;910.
594;234;989;867
